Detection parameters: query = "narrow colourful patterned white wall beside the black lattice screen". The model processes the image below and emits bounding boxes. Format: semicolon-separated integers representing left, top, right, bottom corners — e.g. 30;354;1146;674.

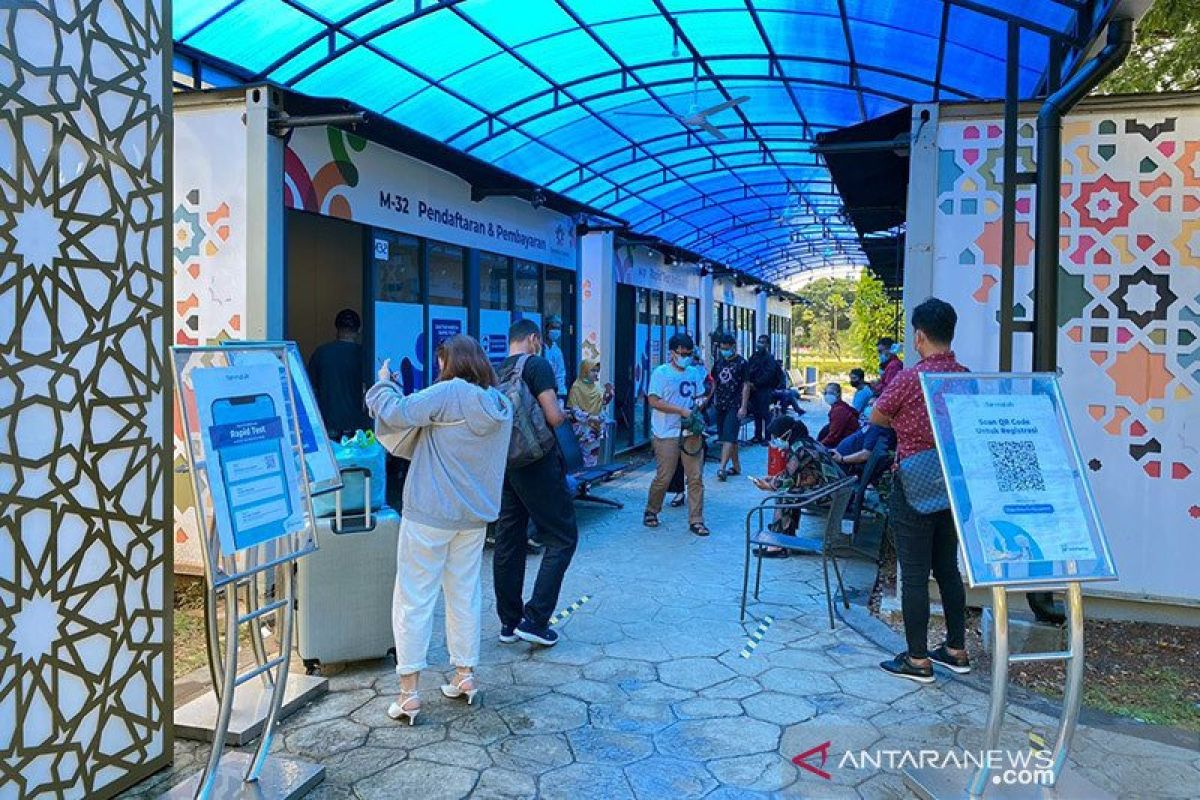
172;102;246;575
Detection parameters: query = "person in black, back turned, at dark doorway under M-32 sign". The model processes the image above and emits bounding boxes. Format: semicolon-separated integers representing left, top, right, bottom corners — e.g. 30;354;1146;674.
308;308;371;441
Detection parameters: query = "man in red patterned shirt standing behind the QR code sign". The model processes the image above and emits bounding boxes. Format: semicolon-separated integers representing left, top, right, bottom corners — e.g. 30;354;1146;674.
871;297;971;684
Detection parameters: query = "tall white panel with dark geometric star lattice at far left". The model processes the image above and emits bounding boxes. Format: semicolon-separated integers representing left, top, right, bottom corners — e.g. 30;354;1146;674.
0;0;170;798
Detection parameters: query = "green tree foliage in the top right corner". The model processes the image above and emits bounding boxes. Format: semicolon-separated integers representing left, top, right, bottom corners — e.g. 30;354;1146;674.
1098;0;1200;95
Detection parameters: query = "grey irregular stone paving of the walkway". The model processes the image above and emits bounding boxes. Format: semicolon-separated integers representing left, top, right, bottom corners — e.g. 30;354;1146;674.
130;449;1200;800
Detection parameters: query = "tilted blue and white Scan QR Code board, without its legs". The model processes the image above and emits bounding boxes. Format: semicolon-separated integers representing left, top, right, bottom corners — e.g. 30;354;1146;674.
920;373;1116;587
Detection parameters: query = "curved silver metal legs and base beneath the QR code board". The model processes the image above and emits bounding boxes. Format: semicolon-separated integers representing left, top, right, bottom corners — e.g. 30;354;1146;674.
905;581;1110;800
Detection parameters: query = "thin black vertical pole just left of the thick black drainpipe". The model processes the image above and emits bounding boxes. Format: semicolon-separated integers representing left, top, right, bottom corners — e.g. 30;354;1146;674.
1000;22;1021;372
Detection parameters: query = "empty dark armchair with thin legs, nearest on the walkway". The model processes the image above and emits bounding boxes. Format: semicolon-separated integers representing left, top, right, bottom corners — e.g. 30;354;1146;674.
740;475;858;630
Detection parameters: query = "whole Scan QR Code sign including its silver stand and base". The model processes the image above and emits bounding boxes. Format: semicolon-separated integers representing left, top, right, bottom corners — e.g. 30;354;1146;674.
905;372;1117;799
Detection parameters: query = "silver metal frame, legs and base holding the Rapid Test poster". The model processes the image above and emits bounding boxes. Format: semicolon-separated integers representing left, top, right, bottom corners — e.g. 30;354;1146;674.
160;344;328;800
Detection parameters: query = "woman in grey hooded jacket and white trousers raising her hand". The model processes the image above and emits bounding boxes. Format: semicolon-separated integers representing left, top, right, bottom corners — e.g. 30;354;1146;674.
366;336;512;724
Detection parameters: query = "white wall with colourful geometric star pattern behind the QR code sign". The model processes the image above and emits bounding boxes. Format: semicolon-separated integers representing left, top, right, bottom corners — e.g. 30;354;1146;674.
934;101;1200;600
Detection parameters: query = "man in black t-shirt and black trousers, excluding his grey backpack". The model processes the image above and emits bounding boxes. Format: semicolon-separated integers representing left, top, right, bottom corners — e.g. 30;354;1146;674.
492;319;580;646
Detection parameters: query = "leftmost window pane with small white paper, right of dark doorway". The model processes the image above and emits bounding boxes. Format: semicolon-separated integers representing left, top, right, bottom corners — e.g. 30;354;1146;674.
371;229;427;393
